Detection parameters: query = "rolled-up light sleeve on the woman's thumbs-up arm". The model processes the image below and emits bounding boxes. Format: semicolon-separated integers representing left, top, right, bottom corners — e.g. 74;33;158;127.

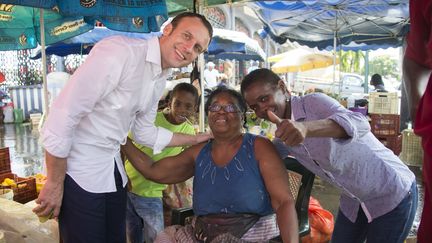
306;93;370;143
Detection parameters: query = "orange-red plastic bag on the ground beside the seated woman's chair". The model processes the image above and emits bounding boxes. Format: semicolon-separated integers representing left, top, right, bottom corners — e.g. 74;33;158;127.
302;197;334;243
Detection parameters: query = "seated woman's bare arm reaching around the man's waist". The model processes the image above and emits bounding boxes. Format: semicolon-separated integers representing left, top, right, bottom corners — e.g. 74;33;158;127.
121;138;199;184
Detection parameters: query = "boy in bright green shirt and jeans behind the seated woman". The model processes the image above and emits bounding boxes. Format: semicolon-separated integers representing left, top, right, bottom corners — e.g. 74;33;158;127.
125;83;198;243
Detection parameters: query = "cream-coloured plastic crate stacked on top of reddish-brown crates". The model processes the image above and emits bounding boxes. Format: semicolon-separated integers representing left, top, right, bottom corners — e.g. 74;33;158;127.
368;92;399;115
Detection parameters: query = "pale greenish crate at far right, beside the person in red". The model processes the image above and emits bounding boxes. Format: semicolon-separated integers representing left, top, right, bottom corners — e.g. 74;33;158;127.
399;129;423;166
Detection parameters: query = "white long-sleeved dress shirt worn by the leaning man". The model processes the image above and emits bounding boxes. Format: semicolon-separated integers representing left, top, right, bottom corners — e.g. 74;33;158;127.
42;36;172;193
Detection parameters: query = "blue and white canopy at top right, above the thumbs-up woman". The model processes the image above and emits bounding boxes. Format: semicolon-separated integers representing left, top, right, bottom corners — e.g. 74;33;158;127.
248;0;409;50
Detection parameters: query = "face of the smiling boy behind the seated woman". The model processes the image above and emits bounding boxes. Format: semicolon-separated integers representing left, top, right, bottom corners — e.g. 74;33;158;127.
169;90;196;124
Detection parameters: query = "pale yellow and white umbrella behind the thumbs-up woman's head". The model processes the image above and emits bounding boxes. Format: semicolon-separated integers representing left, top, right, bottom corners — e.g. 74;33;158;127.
269;48;339;74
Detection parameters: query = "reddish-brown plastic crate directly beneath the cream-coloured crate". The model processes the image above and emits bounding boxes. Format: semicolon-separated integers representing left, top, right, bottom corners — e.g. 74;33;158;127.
370;114;400;137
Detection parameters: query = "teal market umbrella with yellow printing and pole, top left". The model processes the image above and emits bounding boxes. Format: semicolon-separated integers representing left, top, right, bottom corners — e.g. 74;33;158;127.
0;0;168;117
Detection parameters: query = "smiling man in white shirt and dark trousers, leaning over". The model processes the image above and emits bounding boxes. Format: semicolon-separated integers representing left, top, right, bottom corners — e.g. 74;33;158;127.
33;13;213;243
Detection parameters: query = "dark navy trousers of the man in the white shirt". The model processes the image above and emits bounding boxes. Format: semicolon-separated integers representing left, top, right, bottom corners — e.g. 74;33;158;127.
59;163;126;243
